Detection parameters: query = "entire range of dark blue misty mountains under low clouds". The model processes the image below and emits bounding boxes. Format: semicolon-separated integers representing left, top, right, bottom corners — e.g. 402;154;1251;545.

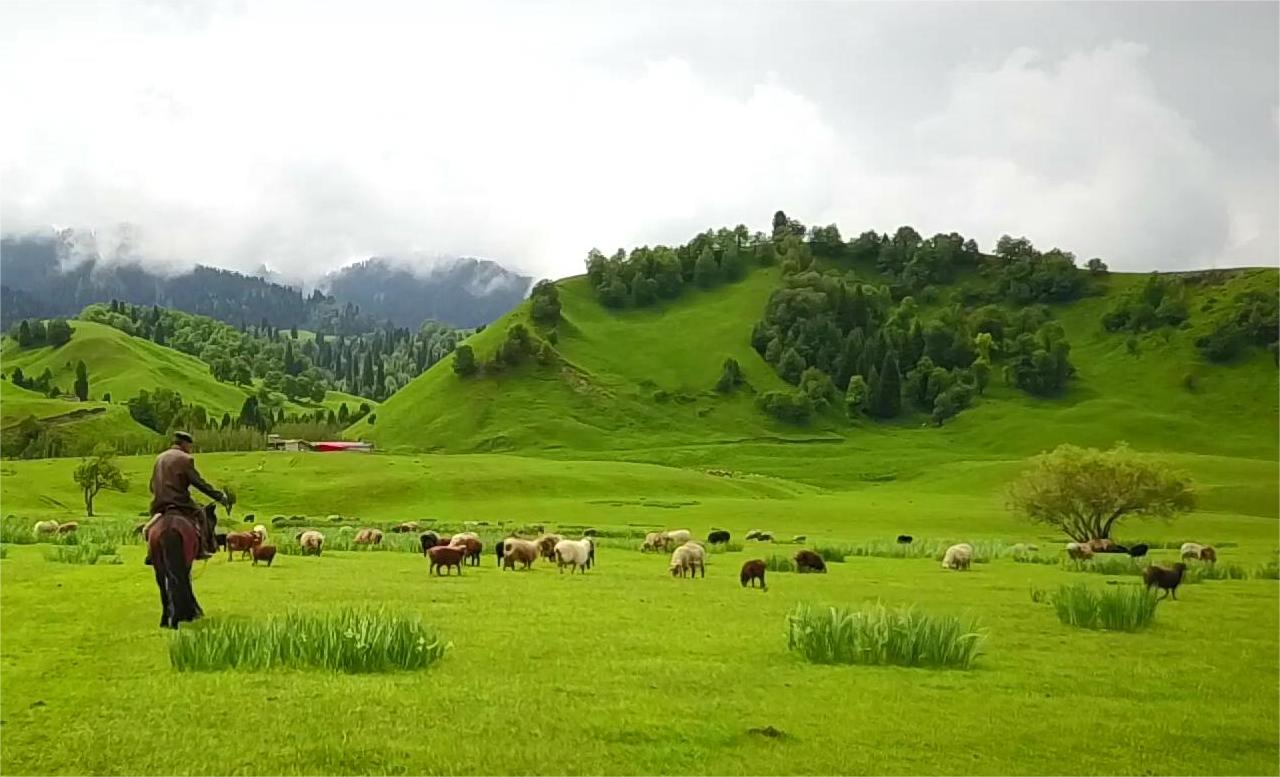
0;230;530;334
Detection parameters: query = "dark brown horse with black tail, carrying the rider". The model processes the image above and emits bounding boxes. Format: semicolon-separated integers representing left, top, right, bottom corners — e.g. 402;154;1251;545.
147;504;218;629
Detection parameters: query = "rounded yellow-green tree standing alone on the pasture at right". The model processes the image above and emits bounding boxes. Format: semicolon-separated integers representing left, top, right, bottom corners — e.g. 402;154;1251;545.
1009;443;1196;541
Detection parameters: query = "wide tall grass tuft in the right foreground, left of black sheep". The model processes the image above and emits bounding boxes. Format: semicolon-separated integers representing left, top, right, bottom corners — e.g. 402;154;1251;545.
787;603;984;669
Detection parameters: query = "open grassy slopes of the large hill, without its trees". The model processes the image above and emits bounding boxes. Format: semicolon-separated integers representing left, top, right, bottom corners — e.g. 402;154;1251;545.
360;269;1280;480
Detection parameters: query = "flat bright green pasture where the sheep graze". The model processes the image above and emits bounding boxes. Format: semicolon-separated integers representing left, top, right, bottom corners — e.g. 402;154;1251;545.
0;454;1280;774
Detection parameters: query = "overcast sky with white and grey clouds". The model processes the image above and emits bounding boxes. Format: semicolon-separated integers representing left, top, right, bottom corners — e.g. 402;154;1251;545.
0;0;1280;278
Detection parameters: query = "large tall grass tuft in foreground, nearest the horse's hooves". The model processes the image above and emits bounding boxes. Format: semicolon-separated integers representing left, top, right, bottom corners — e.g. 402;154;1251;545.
169;608;451;673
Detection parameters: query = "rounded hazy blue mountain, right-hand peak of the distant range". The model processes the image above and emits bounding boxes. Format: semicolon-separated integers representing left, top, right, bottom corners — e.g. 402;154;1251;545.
324;257;532;328
